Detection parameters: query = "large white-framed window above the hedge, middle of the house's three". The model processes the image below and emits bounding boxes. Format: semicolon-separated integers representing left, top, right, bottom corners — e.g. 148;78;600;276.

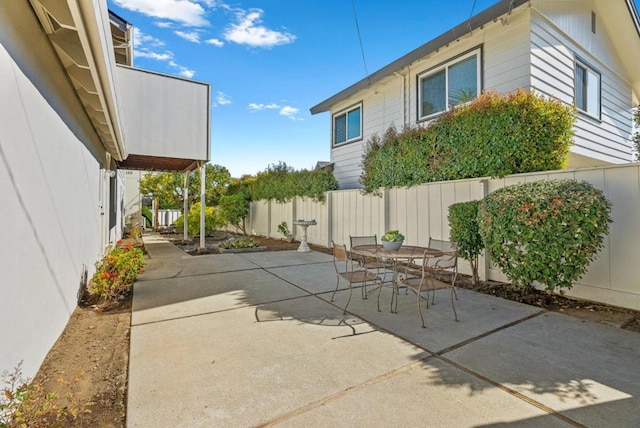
418;49;480;120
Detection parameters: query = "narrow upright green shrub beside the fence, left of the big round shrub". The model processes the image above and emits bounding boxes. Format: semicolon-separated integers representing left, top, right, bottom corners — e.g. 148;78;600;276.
449;201;484;284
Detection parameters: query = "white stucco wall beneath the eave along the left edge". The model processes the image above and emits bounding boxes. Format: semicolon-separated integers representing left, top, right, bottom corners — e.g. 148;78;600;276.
0;1;108;376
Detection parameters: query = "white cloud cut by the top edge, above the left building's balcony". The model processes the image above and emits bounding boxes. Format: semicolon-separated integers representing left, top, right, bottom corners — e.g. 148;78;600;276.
113;0;208;27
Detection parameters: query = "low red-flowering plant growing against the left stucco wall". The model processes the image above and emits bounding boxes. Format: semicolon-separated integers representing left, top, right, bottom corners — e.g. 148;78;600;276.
89;245;144;300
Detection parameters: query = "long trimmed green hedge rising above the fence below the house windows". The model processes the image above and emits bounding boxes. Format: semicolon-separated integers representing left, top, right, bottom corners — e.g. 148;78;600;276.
360;90;576;194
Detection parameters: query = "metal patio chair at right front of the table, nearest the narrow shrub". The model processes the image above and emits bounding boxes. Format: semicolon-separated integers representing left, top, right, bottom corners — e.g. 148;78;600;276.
406;238;458;328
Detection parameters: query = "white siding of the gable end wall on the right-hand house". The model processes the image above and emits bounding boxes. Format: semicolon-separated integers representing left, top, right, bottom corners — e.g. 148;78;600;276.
531;1;632;166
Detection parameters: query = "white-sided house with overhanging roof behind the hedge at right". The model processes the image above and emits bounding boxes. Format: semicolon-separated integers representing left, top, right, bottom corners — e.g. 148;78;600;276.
311;0;640;189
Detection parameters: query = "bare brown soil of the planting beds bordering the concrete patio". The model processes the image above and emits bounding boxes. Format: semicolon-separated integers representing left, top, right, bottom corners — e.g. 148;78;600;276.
27;234;640;428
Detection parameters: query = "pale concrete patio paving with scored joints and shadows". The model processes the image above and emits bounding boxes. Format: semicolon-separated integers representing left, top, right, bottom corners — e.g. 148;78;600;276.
127;236;640;428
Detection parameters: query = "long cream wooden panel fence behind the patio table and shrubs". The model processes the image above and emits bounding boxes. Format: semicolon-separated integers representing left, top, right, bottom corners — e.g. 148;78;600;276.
247;164;640;310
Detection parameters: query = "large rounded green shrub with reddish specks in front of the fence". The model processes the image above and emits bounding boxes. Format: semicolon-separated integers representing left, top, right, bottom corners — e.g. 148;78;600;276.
478;180;611;292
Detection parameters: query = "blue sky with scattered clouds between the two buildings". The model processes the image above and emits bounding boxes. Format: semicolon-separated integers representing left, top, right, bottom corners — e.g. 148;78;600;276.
108;0;637;177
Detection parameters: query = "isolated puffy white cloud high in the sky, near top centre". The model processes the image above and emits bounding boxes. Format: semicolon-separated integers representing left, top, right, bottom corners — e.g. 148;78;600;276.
224;9;296;48
